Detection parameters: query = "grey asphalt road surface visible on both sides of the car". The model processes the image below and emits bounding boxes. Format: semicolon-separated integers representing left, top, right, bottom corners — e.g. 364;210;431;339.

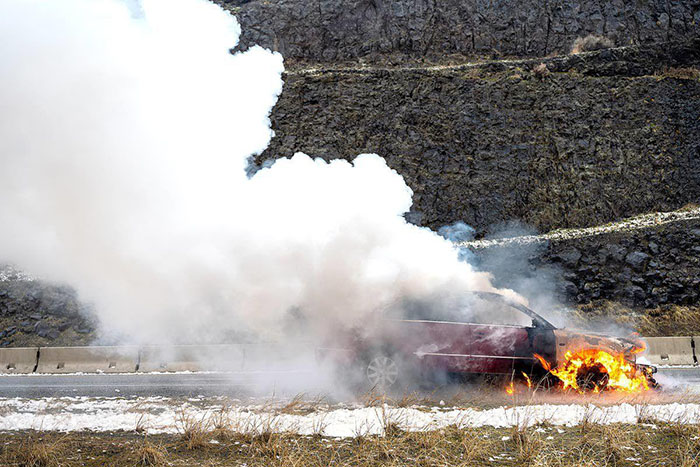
0;368;700;398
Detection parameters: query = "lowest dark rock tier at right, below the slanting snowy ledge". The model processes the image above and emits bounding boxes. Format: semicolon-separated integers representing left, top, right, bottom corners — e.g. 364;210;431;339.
473;216;700;310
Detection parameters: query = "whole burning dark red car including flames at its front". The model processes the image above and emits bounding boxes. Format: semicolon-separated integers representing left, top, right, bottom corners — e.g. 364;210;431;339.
319;292;656;392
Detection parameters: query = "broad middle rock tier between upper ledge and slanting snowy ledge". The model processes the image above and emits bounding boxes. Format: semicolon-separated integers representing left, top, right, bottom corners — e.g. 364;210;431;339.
257;41;700;232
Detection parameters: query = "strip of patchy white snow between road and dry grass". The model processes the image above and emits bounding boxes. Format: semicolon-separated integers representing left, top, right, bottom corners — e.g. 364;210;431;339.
0;397;700;437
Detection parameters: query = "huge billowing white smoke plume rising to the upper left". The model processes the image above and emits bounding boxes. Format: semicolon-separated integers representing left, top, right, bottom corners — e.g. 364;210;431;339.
0;0;516;343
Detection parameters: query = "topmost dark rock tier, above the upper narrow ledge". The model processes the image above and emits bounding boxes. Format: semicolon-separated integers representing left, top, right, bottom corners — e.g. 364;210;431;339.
221;0;700;62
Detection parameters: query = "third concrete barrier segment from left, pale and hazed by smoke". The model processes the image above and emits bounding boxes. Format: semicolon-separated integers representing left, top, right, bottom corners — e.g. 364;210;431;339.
138;344;243;372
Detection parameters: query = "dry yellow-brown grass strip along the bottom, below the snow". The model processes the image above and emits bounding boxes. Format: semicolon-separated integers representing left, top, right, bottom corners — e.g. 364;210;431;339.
0;420;700;467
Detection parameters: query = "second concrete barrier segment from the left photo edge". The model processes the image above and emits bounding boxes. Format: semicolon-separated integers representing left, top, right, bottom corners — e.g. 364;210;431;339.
36;346;139;373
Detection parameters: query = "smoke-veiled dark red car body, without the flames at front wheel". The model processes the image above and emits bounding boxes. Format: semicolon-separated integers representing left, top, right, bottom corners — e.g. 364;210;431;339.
319;292;652;389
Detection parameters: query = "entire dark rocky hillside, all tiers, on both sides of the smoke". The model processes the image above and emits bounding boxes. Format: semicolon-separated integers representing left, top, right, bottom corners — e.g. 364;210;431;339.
0;0;700;347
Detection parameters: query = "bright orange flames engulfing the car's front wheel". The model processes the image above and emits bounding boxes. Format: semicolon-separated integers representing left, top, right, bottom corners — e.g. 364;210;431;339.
535;347;649;393
